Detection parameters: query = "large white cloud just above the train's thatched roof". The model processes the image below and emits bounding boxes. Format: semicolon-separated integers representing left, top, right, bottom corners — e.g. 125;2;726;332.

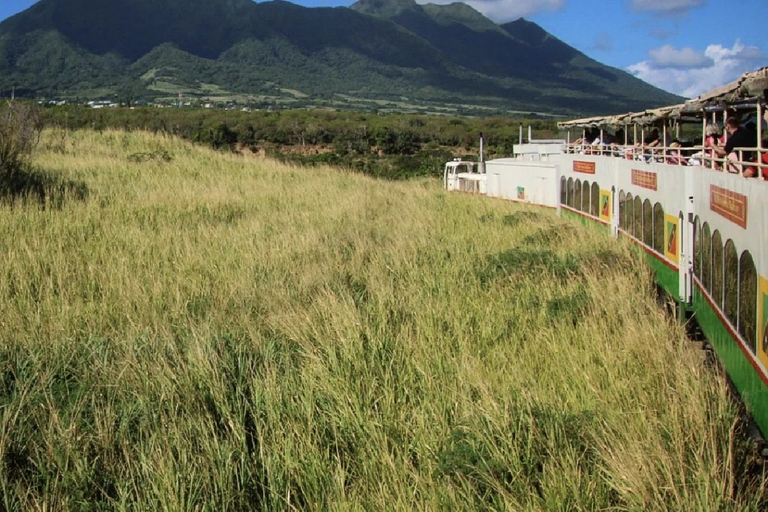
627;40;768;98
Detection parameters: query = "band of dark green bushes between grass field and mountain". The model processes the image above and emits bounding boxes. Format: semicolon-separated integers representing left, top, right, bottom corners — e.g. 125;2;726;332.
43;106;557;179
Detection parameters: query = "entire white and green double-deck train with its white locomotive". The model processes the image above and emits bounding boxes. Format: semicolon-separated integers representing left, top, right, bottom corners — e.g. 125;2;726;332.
446;68;768;436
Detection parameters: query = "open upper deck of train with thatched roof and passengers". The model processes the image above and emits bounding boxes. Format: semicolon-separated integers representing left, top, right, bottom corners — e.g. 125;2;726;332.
558;68;768;181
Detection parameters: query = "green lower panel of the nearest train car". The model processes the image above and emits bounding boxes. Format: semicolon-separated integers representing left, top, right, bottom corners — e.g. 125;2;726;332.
693;288;768;435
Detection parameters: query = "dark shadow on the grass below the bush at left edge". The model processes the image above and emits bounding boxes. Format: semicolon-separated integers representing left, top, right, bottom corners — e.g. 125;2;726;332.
0;165;89;208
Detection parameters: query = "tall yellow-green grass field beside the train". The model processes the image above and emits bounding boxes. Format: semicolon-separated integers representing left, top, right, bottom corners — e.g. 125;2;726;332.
0;131;765;511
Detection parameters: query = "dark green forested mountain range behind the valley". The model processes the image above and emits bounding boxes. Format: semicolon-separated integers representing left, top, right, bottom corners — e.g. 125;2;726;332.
0;0;681;114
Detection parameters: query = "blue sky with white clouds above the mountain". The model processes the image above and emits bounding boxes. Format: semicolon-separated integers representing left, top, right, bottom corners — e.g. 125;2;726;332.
0;0;768;98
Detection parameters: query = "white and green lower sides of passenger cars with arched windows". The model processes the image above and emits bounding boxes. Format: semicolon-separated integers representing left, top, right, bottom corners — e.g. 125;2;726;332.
553;154;768;435
